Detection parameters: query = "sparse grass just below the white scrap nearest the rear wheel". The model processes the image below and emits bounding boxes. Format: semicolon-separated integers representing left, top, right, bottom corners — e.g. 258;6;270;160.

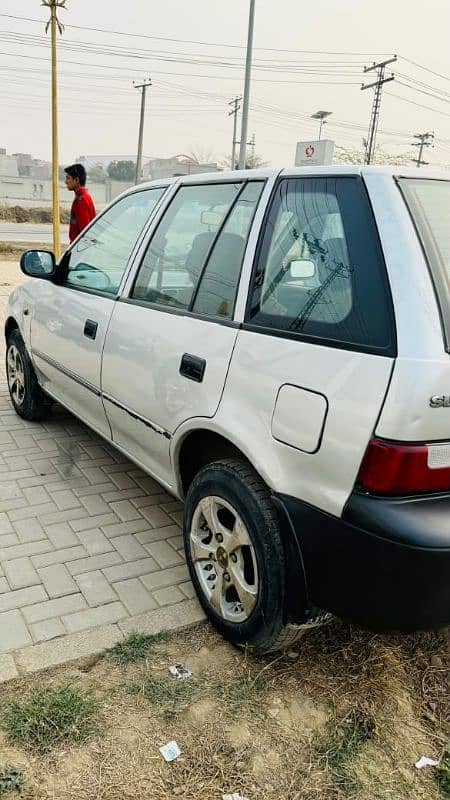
129;675;199;720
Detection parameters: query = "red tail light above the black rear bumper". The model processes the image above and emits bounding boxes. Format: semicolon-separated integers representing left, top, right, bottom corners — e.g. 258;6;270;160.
358;439;450;495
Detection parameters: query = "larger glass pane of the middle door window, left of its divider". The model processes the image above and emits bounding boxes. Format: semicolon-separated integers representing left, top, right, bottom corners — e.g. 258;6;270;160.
131;183;242;309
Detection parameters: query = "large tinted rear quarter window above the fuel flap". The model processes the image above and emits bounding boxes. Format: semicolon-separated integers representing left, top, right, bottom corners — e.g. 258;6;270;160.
247;177;393;350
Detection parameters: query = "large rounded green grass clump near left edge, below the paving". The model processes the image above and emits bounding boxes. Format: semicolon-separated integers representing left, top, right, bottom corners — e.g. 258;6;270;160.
0;686;98;752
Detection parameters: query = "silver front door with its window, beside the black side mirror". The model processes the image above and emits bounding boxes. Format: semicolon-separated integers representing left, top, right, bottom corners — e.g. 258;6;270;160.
31;187;164;437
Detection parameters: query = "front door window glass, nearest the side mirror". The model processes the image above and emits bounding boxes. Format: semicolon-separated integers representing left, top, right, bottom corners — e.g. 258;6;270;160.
64;187;165;294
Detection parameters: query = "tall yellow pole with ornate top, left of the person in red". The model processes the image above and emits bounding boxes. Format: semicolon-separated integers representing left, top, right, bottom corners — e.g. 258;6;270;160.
42;0;66;260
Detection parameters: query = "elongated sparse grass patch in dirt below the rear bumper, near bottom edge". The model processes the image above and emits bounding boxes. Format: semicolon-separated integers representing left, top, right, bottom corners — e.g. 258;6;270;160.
318;709;375;793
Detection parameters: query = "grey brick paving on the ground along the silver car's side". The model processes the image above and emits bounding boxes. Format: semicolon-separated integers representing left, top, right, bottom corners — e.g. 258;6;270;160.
0;262;203;681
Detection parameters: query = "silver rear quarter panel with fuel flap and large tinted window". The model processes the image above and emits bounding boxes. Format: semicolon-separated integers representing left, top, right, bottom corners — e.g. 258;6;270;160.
221;170;396;515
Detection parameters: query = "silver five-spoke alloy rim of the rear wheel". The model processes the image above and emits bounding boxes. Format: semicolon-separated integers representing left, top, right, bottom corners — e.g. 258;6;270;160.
190;497;259;622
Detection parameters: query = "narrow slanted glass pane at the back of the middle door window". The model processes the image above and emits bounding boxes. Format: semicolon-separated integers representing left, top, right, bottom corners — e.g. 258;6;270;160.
192;181;264;319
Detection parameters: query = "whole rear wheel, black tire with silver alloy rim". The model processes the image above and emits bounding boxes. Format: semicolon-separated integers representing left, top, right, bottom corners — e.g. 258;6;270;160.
183;459;304;653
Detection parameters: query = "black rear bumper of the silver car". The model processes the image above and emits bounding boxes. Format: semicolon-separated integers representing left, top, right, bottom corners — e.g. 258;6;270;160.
278;493;450;631
